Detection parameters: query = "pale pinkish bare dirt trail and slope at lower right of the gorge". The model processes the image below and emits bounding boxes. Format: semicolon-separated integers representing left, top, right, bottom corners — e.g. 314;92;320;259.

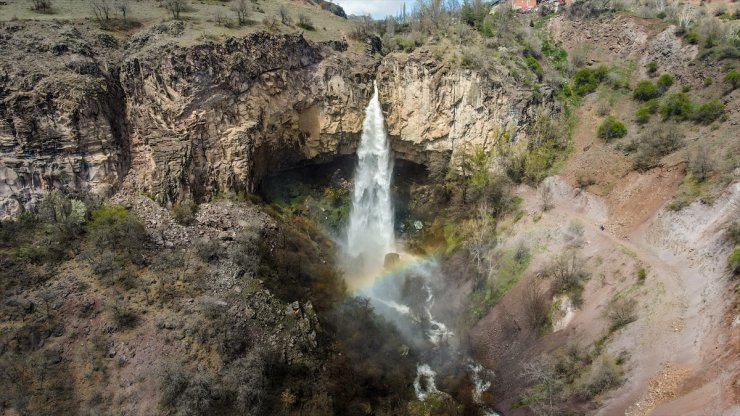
548;177;740;416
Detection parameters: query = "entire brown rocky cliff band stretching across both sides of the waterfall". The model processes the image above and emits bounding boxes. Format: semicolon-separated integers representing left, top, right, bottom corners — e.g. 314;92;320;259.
0;22;537;215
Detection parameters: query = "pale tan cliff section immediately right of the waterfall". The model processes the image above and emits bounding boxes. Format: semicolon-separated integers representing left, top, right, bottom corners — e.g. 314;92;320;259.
378;51;540;172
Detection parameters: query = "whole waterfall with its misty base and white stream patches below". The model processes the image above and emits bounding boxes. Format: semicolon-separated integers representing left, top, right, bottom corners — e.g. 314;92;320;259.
343;83;496;415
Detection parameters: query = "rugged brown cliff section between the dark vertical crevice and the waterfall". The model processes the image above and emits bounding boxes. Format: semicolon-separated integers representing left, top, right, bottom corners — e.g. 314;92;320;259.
122;33;372;202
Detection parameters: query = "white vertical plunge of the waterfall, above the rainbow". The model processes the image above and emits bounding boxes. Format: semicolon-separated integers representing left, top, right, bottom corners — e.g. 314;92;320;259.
345;83;395;274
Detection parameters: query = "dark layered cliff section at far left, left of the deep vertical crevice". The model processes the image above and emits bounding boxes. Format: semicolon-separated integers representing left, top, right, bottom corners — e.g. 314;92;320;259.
0;23;129;215
